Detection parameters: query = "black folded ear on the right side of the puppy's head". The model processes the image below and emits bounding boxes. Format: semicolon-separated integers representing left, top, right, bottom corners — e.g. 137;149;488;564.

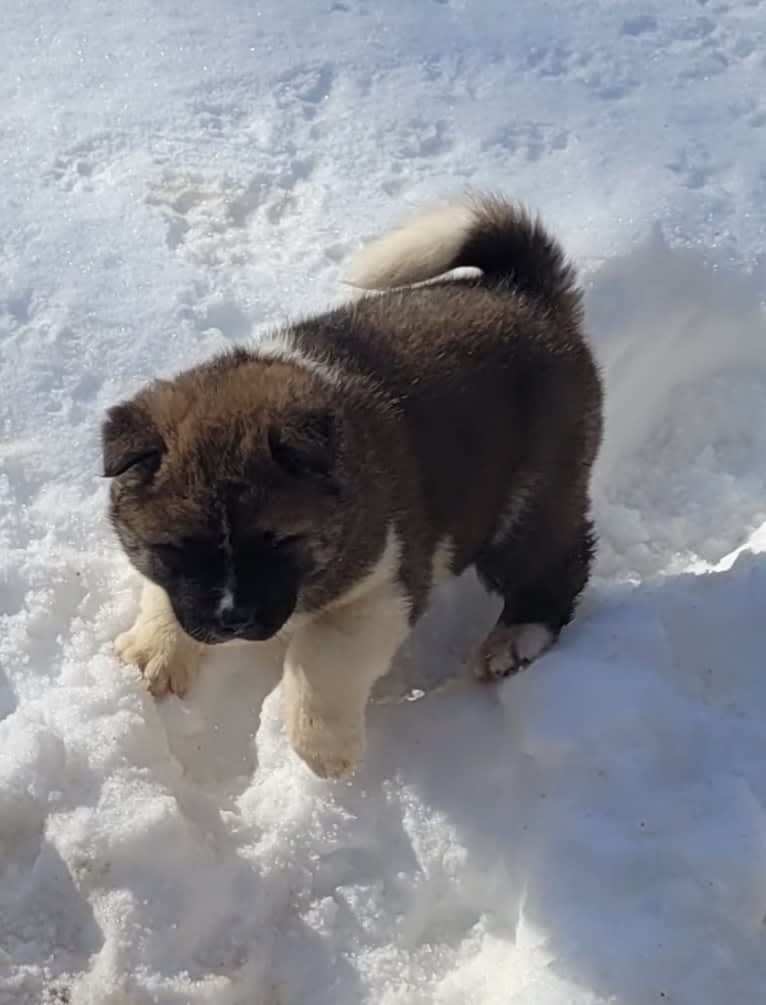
268;411;337;481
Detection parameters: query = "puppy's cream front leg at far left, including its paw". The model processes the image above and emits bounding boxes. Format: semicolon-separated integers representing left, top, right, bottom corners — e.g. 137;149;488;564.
115;580;203;697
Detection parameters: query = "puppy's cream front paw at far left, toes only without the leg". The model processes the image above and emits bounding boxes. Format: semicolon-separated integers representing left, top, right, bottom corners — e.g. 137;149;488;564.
115;620;201;697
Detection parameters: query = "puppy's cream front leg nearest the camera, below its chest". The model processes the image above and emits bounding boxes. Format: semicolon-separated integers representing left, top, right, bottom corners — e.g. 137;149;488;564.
282;592;409;778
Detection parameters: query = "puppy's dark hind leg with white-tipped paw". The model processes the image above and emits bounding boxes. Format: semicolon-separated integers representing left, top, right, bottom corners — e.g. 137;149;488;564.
473;507;595;681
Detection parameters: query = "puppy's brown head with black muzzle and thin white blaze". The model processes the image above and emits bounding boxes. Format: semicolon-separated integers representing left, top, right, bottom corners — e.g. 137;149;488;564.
103;352;344;643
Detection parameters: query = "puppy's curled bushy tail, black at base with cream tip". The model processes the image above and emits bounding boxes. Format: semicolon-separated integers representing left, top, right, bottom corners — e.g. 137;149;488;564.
346;190;580;310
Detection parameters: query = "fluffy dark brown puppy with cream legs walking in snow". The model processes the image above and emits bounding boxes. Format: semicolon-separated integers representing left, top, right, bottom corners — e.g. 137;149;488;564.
103;197;602;778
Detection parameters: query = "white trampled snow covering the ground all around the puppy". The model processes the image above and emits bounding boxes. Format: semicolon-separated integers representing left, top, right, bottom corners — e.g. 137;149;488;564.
0;0;766;1005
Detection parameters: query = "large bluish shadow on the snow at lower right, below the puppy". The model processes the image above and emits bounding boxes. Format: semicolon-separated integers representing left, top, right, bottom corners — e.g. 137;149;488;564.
361;554;766;1005
